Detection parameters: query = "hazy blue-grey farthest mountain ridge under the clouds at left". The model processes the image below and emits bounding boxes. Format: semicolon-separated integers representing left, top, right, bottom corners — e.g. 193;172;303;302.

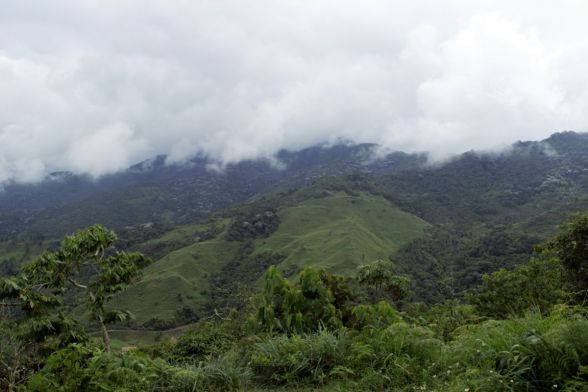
0;144;424;238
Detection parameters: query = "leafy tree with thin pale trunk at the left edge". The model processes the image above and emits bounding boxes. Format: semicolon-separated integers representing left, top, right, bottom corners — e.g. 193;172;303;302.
0;225;151;351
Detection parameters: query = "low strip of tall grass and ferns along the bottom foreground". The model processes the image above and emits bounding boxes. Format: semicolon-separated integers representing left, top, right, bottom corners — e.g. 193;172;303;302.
29;307;588;391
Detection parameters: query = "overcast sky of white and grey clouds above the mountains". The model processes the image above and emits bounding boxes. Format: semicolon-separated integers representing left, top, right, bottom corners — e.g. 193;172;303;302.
0;0;588;182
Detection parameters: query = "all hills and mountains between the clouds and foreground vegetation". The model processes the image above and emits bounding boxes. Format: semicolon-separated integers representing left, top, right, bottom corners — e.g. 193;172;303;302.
0;132;588;328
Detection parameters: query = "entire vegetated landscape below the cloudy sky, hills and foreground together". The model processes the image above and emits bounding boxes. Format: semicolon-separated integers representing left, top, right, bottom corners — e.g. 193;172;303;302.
0;133;588;392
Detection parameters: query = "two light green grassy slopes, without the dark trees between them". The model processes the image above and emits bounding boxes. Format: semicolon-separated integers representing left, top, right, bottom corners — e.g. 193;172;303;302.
112;192;429;328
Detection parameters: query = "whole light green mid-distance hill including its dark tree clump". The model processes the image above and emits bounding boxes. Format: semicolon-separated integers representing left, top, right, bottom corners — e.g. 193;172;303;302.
110;192;429;329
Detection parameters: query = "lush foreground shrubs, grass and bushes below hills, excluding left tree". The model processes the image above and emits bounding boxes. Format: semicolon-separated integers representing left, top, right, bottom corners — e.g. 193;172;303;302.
0;215;588;392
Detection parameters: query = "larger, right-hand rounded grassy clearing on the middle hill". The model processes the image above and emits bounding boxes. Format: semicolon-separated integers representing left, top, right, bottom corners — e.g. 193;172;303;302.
256;192;430;274
